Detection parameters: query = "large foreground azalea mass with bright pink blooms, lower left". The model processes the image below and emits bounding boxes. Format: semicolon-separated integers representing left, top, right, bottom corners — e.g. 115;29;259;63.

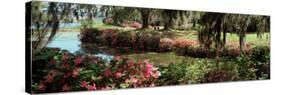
32;48;161;93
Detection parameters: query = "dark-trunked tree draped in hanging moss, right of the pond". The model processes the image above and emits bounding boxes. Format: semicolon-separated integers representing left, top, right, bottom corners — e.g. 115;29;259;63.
198;13;226;51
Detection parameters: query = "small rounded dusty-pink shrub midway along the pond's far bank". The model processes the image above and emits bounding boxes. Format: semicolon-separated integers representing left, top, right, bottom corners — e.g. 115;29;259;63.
159;38;175;51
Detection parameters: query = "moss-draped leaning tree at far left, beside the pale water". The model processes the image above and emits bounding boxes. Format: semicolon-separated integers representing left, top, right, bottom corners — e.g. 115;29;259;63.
31;1;77;49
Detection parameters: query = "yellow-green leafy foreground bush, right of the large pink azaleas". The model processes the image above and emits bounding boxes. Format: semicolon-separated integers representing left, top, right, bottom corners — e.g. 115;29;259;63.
158;59;215;85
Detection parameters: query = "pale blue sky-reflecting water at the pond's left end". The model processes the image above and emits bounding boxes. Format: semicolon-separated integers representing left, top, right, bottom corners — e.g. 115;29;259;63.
47;32;113;61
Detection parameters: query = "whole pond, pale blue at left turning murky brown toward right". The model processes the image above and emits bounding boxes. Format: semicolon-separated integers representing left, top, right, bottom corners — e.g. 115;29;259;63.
47;32;190;64
